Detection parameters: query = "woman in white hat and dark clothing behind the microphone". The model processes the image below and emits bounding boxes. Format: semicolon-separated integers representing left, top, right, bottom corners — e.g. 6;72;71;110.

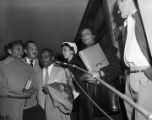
61;42;90;120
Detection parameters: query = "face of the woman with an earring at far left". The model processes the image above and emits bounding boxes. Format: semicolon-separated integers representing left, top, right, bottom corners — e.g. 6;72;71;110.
10;44;23;59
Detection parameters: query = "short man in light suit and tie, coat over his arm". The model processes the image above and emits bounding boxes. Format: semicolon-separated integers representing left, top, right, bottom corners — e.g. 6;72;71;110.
35;49;72;120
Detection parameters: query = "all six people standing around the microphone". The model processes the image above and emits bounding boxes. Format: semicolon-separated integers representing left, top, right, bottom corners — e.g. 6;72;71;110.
0;0;152;120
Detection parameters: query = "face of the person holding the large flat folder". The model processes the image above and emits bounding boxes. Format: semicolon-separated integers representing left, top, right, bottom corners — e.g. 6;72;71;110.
81;28;95;46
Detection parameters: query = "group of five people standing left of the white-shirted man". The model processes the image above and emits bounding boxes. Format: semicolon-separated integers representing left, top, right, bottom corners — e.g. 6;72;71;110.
0;24;120;120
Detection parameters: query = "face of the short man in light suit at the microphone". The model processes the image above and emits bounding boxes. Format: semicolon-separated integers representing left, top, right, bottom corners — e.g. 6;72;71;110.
40;51;54;67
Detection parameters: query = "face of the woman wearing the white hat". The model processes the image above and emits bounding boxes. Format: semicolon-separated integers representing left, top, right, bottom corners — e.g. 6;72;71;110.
62;46;74;60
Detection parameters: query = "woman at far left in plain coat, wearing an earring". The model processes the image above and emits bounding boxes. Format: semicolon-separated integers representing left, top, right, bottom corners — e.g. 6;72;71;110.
0;40;34;120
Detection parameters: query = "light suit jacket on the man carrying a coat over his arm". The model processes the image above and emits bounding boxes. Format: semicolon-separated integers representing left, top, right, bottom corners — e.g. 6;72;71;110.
33;65;70;120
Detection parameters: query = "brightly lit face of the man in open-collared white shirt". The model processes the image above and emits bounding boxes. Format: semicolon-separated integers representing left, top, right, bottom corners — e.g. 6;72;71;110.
117;0;129;19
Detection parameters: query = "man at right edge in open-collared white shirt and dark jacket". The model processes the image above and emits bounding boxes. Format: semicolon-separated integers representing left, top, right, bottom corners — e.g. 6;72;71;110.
117;0;152;120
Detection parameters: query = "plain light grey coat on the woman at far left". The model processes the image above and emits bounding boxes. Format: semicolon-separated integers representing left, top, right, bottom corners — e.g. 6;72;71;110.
0;57;33;120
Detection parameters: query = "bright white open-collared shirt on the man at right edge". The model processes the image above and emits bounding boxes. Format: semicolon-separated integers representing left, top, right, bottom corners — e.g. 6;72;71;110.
124;12;149;67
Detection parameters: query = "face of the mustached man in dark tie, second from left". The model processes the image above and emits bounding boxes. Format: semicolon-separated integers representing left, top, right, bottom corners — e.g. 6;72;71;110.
25;43;38;59
